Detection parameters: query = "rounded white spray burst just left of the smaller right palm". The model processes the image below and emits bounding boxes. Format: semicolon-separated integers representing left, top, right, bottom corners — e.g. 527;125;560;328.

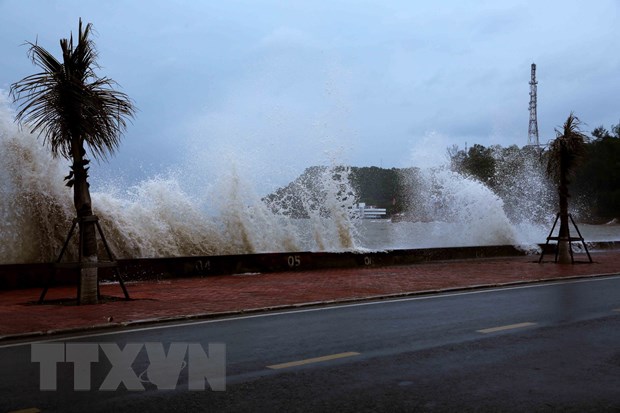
394;166;544;250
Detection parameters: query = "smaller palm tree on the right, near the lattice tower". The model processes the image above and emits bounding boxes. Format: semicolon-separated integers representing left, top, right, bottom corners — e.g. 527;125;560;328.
547;112;588;264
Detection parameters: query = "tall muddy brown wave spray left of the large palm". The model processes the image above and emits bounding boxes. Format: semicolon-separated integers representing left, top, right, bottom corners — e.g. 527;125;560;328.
0;94;73;263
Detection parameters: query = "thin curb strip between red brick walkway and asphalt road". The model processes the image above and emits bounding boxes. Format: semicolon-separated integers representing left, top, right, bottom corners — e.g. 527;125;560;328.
0;272;620;344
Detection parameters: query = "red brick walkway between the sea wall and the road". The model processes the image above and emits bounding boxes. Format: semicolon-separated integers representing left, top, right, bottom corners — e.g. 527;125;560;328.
0;251;620;340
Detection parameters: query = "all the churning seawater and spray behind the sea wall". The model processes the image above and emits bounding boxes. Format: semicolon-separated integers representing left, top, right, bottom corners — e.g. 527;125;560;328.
0;94;620;264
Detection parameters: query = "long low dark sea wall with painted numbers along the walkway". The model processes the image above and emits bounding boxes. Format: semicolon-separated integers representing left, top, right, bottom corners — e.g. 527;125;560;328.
0;241;620;290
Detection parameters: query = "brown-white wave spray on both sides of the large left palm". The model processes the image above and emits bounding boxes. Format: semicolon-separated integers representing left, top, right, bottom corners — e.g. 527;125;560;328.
0;91;356;264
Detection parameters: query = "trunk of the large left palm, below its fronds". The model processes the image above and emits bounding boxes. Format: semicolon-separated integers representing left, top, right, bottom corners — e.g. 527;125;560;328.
72;141;98;304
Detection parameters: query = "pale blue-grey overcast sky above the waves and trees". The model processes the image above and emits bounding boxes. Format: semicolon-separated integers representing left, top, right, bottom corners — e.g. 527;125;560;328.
0;0;620;192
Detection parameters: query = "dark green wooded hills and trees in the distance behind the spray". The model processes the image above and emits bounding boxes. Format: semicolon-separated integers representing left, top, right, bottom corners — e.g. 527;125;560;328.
265;123;620;222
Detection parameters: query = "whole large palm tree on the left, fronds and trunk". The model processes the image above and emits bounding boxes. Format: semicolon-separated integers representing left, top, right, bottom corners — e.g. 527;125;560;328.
11;19;135;304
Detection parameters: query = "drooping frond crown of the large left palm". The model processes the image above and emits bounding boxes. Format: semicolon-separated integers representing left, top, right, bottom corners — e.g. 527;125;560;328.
10;19;135;163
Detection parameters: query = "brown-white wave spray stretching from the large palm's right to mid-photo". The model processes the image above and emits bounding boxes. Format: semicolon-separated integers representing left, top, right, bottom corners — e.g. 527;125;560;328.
93;159;355;257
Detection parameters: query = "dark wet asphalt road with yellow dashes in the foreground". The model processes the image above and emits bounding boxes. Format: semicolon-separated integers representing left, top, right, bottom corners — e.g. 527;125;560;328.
0;276;620;412
